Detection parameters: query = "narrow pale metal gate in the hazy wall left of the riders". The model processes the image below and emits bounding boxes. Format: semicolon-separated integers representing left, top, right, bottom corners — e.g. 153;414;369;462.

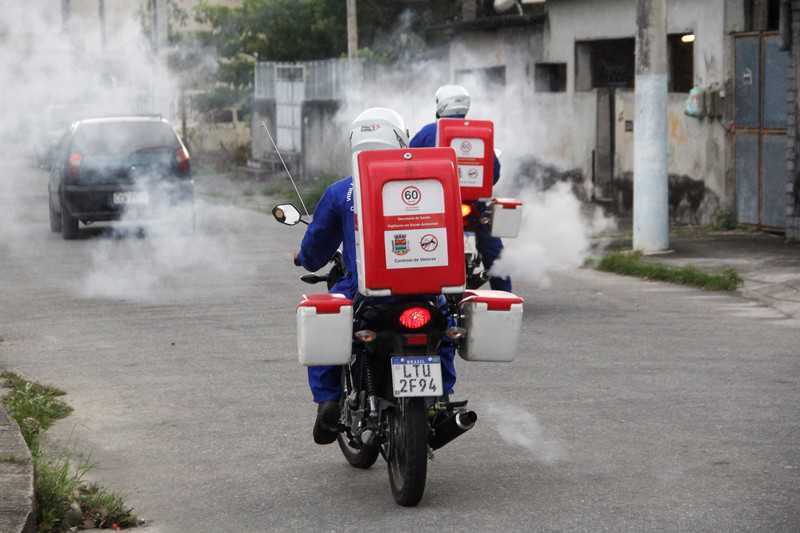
275;64;306;152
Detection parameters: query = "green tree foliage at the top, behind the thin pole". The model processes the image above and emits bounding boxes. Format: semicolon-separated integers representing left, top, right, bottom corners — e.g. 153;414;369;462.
195;0;459;87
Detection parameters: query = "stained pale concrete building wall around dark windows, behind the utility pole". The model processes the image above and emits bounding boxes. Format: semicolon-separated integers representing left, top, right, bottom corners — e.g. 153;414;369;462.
450;0;743;222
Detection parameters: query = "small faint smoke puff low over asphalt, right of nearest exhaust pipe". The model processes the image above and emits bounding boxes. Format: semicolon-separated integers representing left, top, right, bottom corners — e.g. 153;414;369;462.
487;403;565;464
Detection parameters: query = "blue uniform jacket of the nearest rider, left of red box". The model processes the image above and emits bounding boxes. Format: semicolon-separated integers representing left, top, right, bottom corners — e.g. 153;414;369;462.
299;176;358;298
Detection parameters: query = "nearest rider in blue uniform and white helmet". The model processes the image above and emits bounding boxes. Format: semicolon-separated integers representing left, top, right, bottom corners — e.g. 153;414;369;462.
295;108;456;444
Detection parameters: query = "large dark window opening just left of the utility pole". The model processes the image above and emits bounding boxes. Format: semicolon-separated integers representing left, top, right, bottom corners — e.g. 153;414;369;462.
575;39;636;91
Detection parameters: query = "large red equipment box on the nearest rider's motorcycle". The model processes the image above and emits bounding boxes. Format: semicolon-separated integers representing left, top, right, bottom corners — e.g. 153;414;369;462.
353;148;466;296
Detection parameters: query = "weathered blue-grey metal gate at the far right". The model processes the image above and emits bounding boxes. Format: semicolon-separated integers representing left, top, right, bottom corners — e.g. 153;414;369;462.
734;33;790;229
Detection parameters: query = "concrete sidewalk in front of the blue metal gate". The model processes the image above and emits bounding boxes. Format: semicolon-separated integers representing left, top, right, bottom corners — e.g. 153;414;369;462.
617;229;800;317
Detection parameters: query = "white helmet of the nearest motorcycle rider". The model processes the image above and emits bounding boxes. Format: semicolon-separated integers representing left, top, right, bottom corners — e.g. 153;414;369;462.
350;107;409;153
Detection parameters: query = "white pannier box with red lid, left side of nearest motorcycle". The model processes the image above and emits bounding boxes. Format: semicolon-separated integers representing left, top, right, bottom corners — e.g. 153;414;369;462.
297;293;353;366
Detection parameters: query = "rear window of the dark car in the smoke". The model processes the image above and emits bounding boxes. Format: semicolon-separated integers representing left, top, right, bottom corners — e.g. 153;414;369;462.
73;122;178;157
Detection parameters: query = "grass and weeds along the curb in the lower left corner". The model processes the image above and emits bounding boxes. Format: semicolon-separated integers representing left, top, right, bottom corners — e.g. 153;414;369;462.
0;372;138;533
